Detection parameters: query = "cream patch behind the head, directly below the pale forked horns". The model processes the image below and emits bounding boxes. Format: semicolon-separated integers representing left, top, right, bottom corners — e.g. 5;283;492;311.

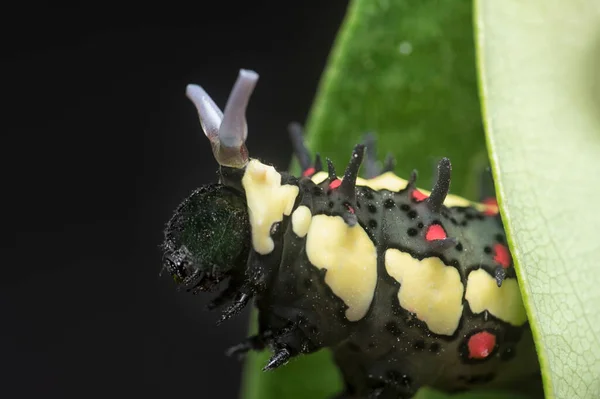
242;159;298;255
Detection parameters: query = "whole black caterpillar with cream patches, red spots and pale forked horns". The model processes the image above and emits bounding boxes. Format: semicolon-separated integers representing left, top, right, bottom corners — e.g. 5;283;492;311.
162;69;539;399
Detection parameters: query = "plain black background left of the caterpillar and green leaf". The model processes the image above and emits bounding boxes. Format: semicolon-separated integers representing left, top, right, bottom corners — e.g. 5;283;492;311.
0;0;347;399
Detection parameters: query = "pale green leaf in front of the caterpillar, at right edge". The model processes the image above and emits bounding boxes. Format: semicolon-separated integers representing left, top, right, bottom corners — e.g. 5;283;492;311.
476;0;600;399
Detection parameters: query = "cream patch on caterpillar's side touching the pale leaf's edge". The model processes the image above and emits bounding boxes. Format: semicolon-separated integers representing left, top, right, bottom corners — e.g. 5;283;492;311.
465;269;527;326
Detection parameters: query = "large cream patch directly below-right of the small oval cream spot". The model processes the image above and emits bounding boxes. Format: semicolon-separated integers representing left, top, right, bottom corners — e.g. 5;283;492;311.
306;215;377;321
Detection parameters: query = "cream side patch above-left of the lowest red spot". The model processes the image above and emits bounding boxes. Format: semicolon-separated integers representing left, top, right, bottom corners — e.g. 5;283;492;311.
385;252;464;335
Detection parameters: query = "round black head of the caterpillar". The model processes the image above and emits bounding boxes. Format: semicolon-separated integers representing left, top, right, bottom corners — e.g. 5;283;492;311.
163;184;251;292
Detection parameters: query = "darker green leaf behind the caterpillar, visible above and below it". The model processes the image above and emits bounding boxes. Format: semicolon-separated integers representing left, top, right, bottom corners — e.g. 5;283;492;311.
243;0;556;399
